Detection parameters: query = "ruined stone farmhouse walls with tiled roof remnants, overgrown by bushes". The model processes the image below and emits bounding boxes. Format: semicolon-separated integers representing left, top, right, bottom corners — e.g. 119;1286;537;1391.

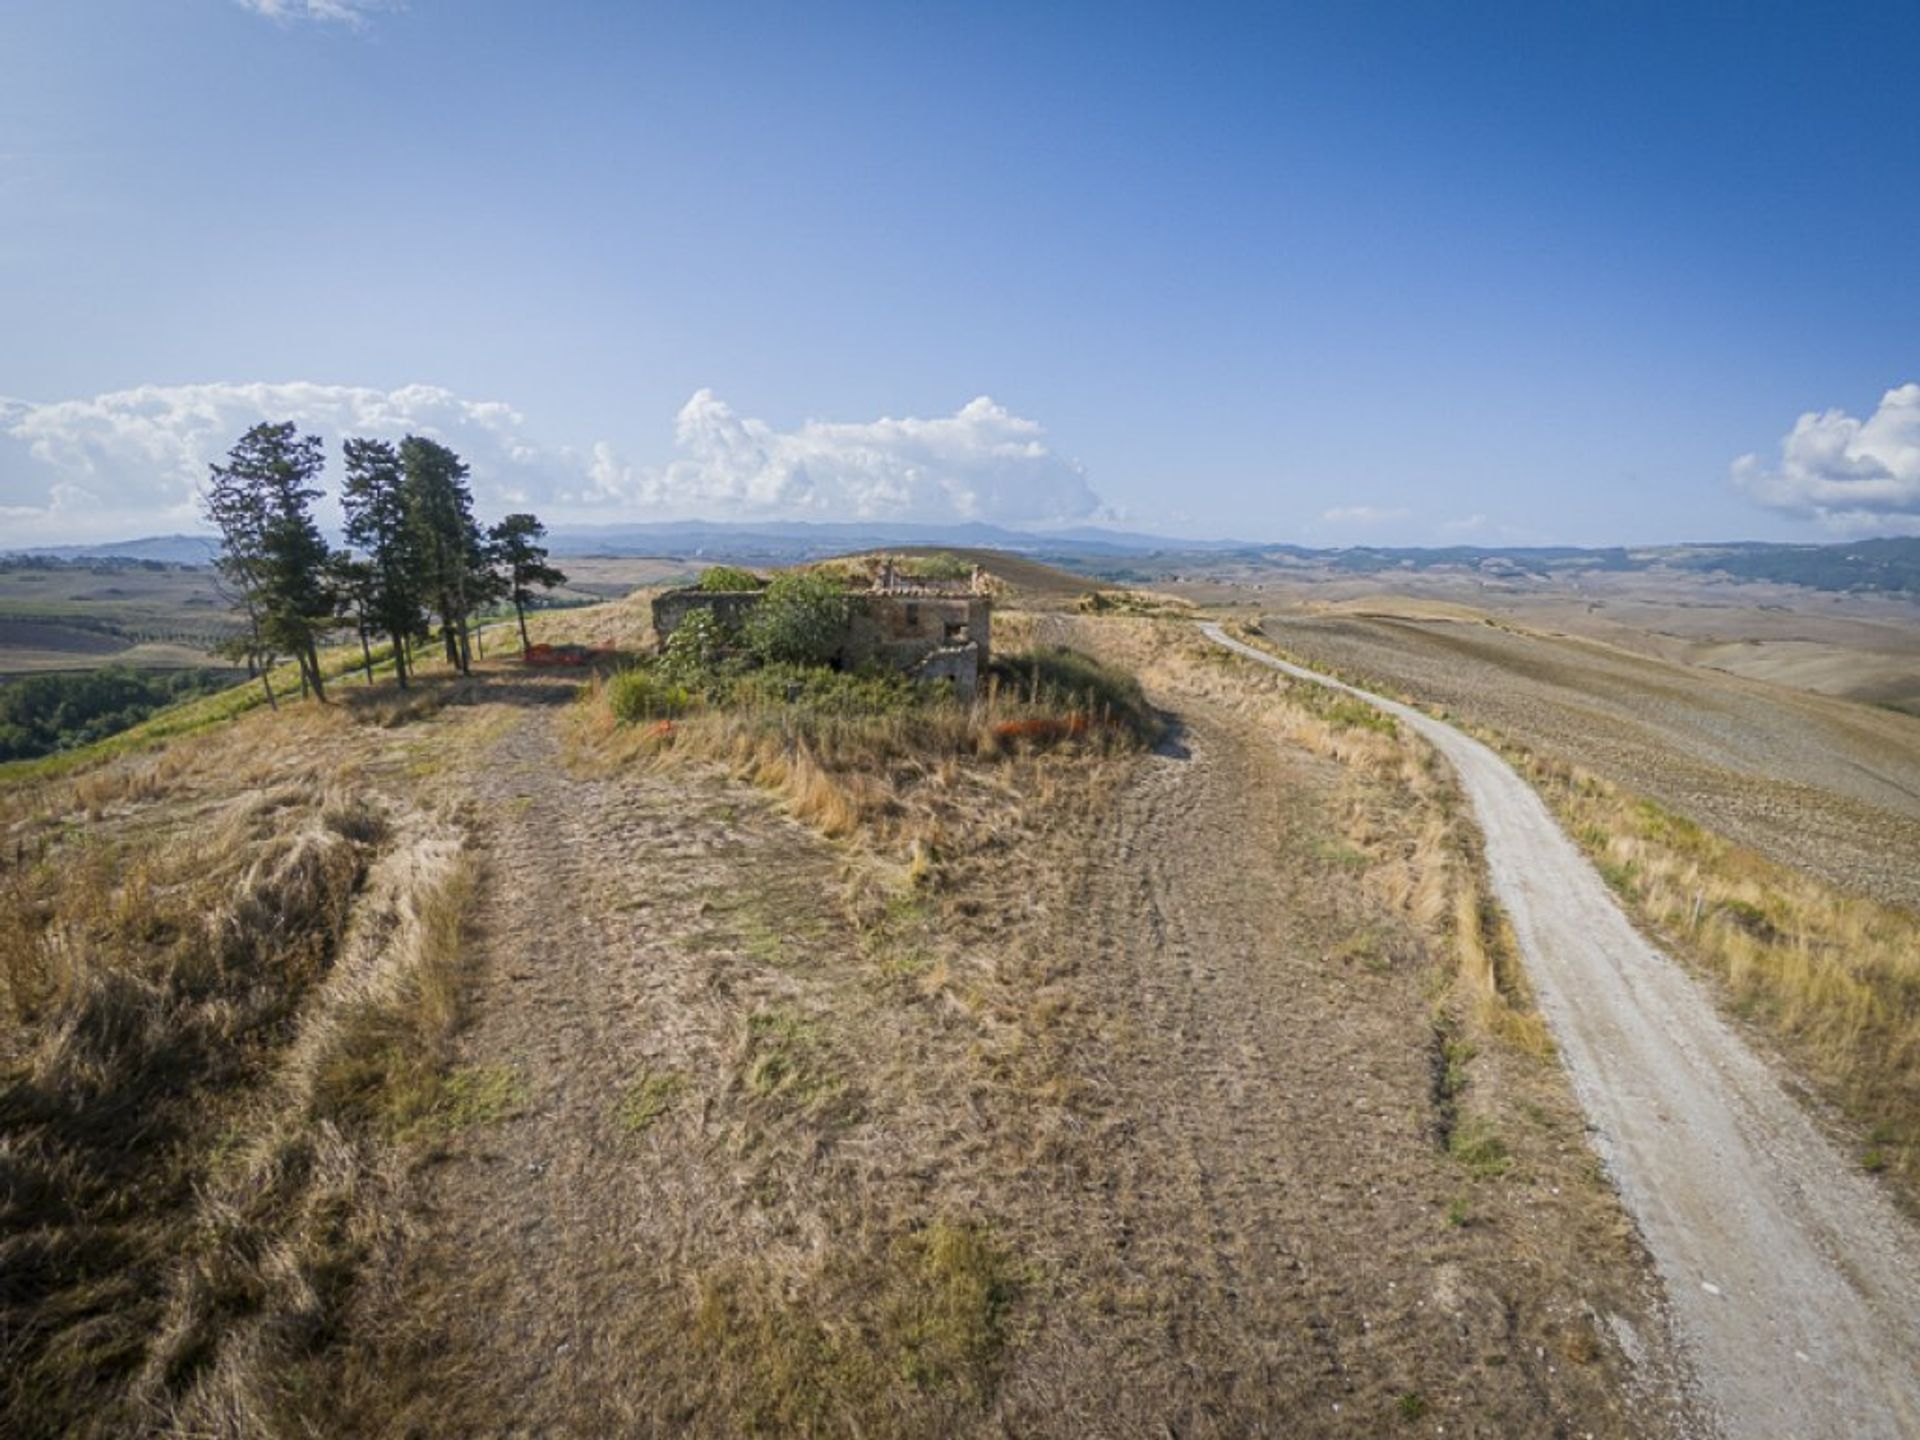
653;561;993;699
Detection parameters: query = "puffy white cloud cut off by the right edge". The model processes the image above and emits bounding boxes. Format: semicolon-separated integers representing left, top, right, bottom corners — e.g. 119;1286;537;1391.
1732;384;1920;534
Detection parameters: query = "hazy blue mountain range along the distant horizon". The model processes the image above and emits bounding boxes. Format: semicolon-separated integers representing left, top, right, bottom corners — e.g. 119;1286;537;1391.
10;520;1920;597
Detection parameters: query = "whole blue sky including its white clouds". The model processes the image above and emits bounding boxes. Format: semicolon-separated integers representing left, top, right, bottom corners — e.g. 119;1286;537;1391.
0;0;1920;543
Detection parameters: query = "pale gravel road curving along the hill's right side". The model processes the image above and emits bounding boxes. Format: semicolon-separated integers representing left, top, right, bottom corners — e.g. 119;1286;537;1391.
1202;624;1920;1440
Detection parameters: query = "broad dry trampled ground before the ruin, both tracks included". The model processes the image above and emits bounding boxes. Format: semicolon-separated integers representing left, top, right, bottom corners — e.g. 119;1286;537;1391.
342;660;1690;1440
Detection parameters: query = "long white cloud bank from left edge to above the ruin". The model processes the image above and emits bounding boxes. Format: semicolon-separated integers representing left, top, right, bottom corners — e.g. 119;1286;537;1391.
0;380;1104;547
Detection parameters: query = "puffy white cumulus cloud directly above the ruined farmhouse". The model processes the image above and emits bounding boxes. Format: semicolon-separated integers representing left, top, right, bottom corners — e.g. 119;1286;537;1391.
589;390;1100;524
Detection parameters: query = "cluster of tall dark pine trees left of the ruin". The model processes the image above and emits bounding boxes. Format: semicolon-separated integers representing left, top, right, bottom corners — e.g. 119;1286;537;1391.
205;422;566;701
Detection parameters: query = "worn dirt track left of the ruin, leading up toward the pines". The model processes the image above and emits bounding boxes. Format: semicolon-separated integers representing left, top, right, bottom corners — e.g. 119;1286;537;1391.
341;684;867;1436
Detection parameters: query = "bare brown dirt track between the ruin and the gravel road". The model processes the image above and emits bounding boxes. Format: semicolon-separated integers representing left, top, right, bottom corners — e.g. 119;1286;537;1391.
1012;697;1678;1436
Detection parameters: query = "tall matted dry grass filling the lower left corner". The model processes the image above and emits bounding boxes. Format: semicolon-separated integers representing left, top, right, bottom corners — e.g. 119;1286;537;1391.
0;691;478;1436
